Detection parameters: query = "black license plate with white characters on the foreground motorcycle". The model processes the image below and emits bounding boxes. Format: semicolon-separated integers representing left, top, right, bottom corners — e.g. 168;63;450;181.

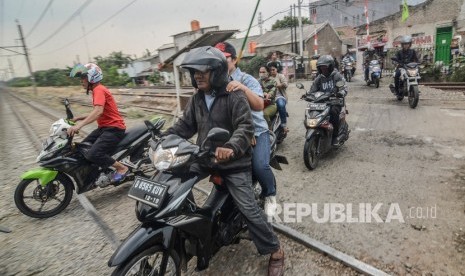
128;177;169;208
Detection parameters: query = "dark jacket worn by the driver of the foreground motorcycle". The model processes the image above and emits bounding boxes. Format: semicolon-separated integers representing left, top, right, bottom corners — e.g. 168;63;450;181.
164;83;254;171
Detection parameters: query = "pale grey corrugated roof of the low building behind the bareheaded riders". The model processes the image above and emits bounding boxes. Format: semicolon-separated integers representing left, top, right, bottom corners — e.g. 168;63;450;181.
257;22;329;48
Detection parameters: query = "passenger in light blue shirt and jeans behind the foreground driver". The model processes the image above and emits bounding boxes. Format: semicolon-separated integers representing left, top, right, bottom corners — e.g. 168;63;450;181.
215;42;277;216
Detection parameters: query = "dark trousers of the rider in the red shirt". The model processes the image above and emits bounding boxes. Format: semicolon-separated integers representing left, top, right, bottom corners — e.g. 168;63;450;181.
82;127;124;168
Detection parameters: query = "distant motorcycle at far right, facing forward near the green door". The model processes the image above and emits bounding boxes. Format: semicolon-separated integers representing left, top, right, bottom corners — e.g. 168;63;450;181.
389;57;421;108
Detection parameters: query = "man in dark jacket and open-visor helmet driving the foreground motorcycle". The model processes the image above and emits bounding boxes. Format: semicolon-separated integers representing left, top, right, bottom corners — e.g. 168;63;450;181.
165;46;284;275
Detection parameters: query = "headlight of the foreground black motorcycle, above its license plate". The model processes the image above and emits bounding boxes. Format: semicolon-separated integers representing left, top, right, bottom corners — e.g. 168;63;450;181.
149;145;190;171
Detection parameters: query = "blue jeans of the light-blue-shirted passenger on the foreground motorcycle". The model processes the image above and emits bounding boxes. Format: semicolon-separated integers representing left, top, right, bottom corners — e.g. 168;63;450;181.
252;132;276;197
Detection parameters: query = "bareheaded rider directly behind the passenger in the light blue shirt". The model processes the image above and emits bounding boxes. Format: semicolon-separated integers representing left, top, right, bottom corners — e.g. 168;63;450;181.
258;66;278;128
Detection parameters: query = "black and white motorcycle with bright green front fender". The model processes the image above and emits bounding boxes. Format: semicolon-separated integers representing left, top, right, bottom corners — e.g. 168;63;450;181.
14;99;164;218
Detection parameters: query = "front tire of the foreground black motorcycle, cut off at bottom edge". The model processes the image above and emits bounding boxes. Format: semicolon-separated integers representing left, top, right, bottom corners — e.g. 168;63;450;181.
111;245;181;276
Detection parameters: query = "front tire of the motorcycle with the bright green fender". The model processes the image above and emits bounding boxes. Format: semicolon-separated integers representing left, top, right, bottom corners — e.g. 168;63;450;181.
14;174;74;218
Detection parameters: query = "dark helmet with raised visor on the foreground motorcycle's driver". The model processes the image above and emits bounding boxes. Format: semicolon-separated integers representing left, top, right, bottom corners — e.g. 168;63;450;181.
180;46;228;89
